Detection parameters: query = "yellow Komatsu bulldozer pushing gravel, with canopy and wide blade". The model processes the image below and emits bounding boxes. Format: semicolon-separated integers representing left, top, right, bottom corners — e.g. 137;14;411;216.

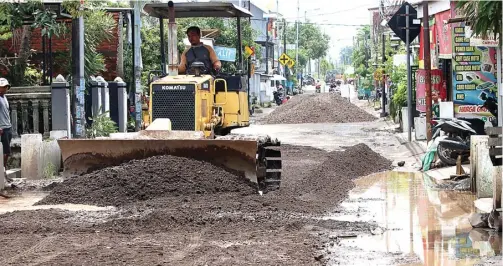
58;1;282;193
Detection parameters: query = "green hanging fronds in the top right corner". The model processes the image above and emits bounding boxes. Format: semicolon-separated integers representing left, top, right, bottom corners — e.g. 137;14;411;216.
456;1;503;43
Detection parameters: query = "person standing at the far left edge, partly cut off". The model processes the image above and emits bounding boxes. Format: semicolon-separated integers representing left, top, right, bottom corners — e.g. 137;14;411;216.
0;78;12;175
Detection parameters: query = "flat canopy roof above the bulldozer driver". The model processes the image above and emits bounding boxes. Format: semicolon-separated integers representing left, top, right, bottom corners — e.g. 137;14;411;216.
143;2;253;18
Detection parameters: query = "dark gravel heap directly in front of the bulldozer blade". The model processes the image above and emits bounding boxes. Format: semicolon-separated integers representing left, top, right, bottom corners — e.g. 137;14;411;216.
37;155;256;206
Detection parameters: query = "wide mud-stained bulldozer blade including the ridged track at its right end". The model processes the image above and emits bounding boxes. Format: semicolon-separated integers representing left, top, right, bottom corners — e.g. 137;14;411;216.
58;136;281;191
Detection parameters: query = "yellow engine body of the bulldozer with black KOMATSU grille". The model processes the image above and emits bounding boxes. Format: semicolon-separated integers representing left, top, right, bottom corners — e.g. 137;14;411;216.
149;75;250;137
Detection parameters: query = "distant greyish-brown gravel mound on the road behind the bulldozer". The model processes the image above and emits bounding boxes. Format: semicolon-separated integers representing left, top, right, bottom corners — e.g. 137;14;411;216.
260;93;376;124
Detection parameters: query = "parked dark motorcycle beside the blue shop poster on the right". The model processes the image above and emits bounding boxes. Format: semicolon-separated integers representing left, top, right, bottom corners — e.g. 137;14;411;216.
432;119;485;166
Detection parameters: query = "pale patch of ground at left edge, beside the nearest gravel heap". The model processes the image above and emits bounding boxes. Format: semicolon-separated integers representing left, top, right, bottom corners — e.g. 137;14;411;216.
0;192;114;214
